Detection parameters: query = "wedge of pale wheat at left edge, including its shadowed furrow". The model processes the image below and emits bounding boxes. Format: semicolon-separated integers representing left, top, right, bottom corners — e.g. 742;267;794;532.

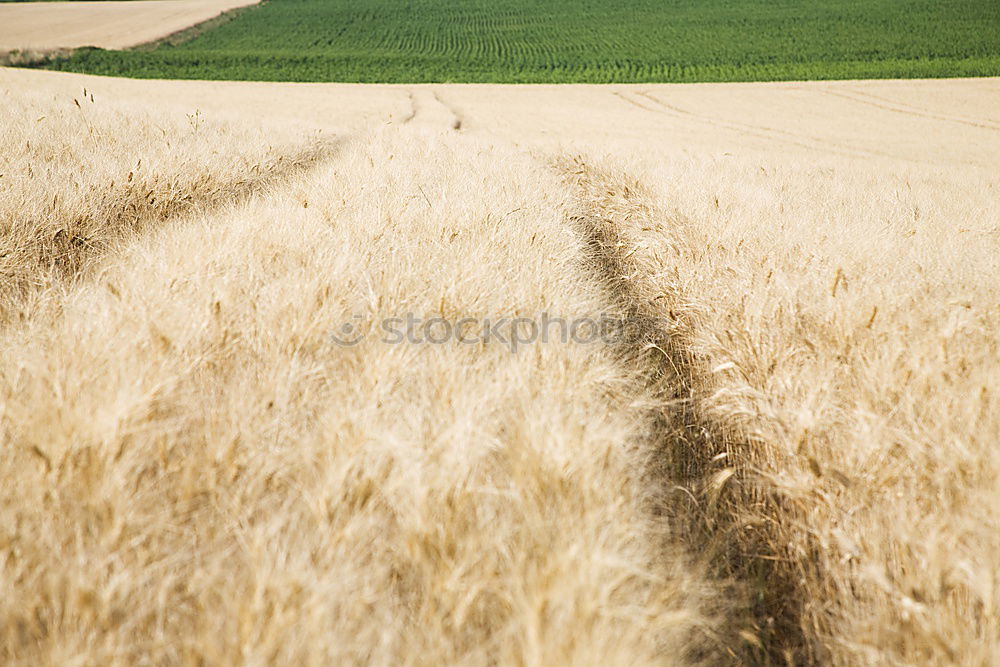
0;88;333;319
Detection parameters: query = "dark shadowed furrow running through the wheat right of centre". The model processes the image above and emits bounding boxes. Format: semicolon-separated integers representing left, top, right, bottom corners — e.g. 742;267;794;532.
553;157;812;664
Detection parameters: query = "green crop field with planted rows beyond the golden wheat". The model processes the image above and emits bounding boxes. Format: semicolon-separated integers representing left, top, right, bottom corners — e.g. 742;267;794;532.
37;0;1000;83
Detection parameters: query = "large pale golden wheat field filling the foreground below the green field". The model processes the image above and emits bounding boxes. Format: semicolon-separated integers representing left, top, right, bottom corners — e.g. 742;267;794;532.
0;69;1000;665
